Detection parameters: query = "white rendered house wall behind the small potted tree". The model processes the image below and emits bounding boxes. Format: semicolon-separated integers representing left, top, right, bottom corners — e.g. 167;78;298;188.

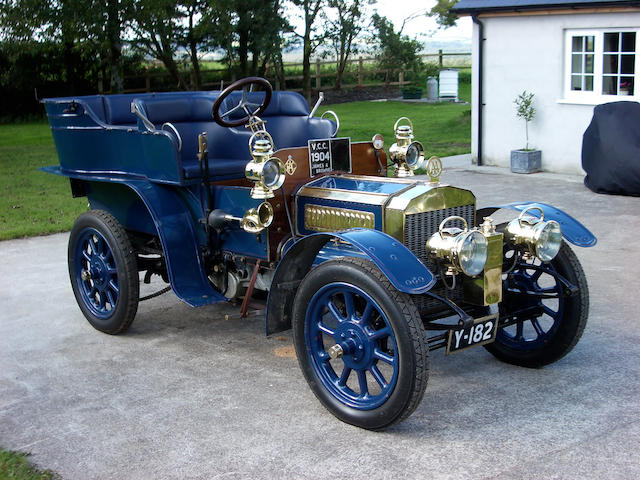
472;13;640;174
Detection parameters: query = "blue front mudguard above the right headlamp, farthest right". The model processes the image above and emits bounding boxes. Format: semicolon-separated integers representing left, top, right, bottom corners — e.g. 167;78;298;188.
477;202;598;247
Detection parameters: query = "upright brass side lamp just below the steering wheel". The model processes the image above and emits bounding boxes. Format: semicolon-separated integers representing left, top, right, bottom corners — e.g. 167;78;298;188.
244;130;285;199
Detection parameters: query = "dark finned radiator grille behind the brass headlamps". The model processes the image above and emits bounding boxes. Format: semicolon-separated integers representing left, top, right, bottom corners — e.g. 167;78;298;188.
404;205;475;311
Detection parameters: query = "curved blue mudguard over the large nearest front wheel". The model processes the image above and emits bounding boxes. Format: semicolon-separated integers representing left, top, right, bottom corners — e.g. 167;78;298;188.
265;228;436;335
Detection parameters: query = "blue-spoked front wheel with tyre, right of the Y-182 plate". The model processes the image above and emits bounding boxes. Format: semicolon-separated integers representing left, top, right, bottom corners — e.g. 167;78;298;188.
485;243;589;367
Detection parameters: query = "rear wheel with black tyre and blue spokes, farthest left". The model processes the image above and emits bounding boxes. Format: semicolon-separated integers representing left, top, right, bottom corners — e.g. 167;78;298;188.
68;210;140;335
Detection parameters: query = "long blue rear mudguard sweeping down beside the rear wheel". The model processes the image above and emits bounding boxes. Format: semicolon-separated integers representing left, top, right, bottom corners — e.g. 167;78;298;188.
43;167;227;307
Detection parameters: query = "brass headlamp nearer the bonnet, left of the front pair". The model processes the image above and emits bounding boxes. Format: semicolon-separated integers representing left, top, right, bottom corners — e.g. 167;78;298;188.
427;216;488;277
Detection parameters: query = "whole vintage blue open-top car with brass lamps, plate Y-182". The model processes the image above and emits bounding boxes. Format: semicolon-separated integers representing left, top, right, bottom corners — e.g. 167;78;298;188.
44;77;596;430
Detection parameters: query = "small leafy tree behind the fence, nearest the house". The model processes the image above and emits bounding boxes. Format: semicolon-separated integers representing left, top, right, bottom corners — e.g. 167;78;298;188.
373;14;423;82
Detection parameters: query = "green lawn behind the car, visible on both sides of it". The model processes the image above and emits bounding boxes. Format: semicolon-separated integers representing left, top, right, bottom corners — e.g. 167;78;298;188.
0;91;471;240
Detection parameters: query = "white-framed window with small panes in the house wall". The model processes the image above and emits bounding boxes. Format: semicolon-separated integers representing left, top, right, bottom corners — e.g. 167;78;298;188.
565;29;640;103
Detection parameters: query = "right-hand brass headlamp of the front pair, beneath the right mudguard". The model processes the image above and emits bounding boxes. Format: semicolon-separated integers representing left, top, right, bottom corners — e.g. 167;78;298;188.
504;205;562;262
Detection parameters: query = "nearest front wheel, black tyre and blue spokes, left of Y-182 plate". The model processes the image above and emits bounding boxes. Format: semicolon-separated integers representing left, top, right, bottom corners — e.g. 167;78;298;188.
293;258;429;430
